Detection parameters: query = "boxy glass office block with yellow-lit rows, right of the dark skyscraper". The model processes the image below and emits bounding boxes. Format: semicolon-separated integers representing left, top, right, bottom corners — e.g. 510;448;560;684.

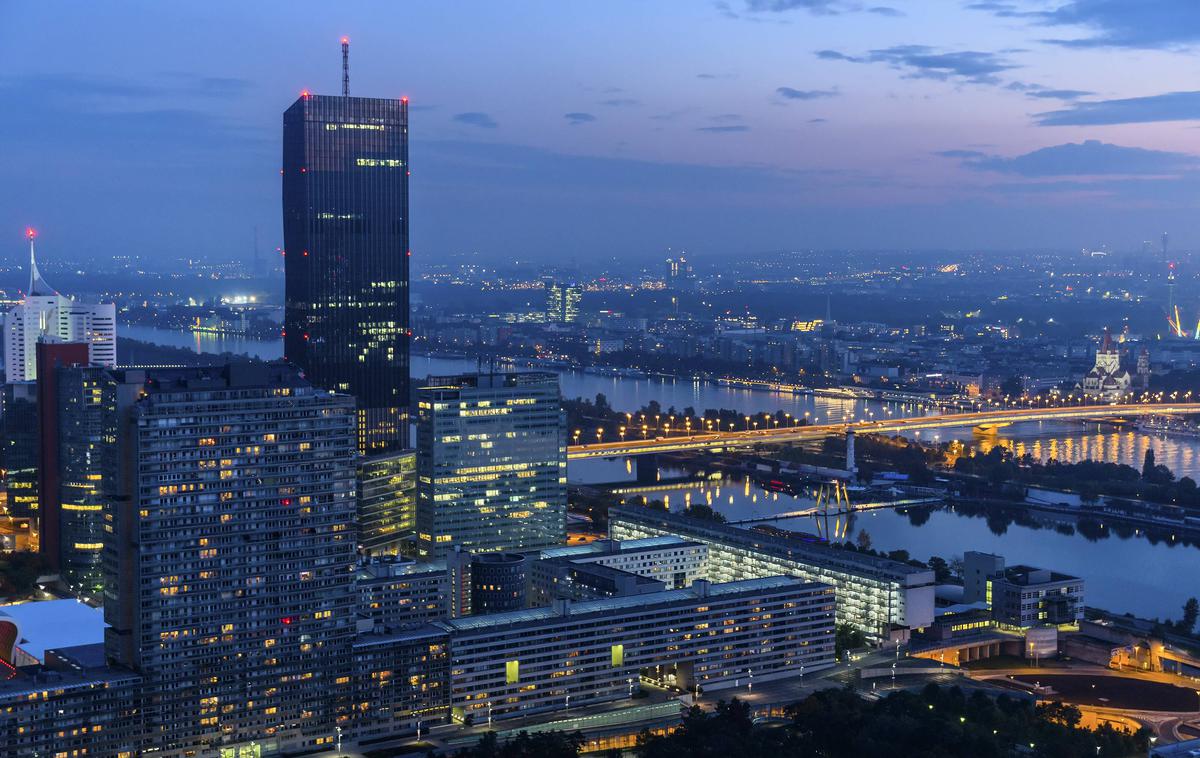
416;373;566;558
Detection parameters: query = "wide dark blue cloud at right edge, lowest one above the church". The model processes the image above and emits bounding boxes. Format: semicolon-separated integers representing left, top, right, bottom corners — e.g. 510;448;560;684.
938;139;1200;178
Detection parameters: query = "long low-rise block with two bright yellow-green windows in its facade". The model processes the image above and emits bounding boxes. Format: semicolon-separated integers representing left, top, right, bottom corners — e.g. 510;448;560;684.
433;576;835;723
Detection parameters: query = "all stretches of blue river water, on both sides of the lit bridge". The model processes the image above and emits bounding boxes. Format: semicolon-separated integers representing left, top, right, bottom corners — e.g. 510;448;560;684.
121;327;1200;618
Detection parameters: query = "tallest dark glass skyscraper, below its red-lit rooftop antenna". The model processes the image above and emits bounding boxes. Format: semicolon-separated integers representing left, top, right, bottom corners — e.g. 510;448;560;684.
283;92;409;453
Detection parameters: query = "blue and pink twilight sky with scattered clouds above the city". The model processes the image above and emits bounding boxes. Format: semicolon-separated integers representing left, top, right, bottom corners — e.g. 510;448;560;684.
0;0;1200;263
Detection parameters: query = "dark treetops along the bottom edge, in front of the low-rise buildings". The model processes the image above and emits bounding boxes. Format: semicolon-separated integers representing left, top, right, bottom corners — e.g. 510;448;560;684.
429;684;1150;758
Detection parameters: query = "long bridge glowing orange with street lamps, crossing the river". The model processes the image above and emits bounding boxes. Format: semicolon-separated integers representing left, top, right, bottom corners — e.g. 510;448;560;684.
566;403;1200;461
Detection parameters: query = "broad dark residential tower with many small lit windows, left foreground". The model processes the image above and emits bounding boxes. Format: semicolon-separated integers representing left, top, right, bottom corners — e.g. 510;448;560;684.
103;363;356;757
